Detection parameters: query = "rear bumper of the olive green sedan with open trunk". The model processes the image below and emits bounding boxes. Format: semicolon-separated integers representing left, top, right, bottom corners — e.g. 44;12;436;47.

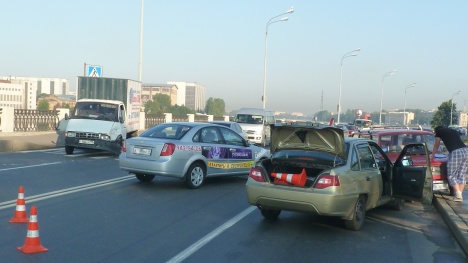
246;178;359;218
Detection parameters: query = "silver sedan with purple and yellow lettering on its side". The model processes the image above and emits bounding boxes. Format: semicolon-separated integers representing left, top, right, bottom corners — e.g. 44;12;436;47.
119;122;270;188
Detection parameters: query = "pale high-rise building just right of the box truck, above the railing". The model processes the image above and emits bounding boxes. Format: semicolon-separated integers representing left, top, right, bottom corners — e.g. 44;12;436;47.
167;81;206;112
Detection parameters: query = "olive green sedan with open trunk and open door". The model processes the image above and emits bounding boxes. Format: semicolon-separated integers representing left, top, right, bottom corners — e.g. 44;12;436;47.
246;125;433;230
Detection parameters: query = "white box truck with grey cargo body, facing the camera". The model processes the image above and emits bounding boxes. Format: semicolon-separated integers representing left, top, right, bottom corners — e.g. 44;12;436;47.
65;77;141;155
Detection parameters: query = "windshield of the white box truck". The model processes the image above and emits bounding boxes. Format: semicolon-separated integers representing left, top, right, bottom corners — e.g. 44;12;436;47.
71;102;119;122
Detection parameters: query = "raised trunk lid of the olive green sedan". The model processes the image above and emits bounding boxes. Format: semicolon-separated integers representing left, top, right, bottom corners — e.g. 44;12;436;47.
270;126;345;159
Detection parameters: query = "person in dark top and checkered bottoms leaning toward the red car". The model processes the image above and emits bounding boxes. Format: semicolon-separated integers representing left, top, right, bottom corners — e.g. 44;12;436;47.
431;126;468;202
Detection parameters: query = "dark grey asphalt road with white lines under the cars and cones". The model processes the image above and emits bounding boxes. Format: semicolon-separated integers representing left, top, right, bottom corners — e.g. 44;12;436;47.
0;148;468;263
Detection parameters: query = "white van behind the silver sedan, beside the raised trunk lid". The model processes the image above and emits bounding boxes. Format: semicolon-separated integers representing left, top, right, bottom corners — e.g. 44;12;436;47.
235;108;276;146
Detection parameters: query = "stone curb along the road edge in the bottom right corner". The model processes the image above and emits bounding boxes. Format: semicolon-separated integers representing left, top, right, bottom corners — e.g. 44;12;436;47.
433;194;468;255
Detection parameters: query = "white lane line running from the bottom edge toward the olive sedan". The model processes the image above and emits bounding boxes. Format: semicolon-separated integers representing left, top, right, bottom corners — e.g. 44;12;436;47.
167;206;256;263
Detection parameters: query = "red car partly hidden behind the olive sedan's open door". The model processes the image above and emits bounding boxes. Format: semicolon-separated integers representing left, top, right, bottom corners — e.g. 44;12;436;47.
355;129;451;191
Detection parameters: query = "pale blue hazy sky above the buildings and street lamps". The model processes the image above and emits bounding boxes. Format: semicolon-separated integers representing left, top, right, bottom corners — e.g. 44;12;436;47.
0;0;468;115
